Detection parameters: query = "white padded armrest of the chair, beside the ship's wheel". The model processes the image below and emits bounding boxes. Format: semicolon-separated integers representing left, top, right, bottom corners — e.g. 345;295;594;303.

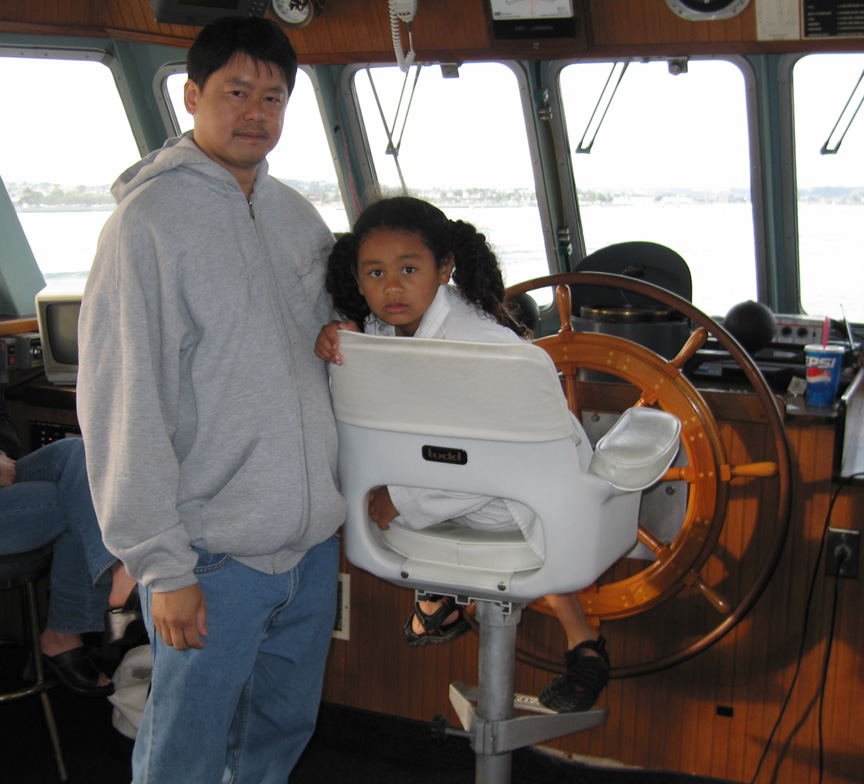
588;407;681;492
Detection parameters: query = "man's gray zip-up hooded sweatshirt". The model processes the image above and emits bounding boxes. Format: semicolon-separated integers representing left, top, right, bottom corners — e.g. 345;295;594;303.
77;135;345;591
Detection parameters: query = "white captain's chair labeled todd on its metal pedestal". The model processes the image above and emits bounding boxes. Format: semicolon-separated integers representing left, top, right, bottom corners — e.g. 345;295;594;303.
330;331;680;784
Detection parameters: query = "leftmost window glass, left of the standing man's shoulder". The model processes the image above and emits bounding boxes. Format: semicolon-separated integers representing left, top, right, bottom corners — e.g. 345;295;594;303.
0;56;140;288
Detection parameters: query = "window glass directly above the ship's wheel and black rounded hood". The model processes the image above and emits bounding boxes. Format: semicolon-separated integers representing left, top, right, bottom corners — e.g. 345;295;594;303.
560;60;756;316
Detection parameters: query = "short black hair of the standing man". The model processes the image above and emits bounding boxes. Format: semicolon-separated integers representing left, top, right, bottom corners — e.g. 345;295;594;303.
186;16;297;95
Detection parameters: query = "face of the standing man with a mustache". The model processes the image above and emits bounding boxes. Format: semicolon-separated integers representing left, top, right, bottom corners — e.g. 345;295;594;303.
184;53;288;195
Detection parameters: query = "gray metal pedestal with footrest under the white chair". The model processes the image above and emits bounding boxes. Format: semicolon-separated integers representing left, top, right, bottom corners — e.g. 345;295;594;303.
450;601;609;784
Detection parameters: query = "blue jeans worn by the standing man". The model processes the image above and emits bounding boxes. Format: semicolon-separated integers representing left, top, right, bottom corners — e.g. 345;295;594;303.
132;536;339;784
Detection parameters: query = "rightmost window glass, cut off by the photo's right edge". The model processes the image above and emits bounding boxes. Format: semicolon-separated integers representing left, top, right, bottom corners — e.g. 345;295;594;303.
792;54;864;322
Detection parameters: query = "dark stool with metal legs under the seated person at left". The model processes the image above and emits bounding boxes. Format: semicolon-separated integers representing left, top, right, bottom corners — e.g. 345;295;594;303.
0;544;68;781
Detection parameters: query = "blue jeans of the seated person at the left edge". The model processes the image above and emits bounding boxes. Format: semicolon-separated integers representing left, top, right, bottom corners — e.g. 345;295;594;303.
0;438;117;634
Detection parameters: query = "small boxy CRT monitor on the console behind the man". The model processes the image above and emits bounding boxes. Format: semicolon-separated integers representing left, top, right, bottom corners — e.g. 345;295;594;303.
36;289;81;386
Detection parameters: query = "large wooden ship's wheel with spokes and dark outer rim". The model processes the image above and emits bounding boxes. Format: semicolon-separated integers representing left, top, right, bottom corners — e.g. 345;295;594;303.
507;273;791;678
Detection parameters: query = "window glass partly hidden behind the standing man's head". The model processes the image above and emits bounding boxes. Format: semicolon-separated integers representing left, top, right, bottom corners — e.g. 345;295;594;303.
165;70;349;231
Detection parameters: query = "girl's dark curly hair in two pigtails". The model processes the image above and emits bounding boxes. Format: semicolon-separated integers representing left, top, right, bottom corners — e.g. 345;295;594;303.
325;196;531;338
